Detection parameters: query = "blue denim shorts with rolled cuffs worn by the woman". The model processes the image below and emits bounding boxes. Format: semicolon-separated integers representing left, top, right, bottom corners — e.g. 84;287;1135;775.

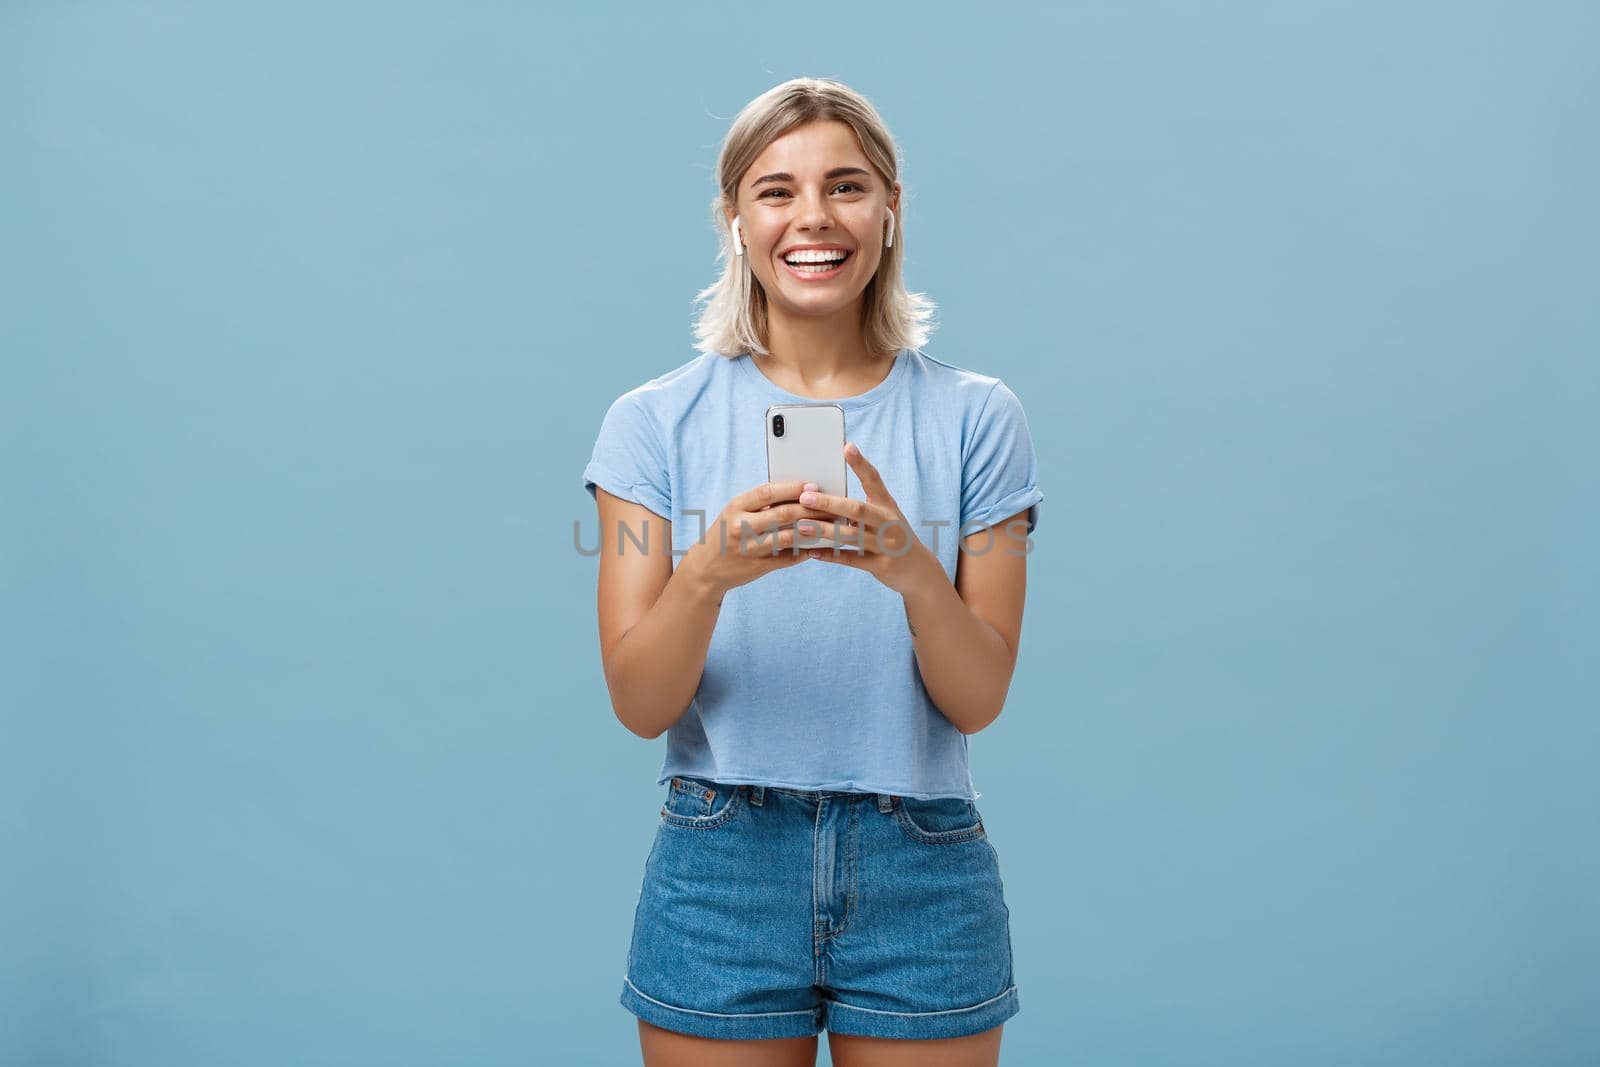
621;776;1019;1038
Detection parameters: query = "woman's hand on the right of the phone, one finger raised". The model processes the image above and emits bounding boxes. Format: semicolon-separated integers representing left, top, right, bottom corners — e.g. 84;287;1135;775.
798;442;950;597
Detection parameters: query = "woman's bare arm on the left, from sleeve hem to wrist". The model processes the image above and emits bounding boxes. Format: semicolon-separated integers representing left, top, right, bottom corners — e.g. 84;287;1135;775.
595;486;722;739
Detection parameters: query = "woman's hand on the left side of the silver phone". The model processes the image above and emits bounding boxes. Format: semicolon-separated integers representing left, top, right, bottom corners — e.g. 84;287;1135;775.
678;482;832;600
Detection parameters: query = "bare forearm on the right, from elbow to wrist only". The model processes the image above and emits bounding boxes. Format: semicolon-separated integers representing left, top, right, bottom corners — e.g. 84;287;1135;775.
906;571;1016;734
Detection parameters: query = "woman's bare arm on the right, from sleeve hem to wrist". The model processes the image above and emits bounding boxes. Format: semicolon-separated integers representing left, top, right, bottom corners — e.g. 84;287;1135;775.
904;510;1027;734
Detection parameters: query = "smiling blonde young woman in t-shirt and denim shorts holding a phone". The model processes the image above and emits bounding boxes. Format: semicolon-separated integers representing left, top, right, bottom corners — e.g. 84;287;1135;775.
584;78;1043;1067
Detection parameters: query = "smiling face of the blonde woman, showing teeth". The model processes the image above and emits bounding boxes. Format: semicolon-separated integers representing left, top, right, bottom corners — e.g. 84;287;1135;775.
728;120;899;315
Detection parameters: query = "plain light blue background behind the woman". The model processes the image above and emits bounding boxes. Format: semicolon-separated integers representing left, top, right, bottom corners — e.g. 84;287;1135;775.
0;0;1600;1067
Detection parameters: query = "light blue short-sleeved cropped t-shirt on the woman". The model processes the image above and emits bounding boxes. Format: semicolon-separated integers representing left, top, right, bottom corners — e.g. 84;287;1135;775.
584;349;1045;800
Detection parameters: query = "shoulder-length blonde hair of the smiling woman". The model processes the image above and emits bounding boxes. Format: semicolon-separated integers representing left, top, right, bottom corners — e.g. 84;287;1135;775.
694;78;936;358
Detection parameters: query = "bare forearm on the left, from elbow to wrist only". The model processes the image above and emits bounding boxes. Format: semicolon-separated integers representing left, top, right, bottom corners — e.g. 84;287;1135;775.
605;553;722;737
